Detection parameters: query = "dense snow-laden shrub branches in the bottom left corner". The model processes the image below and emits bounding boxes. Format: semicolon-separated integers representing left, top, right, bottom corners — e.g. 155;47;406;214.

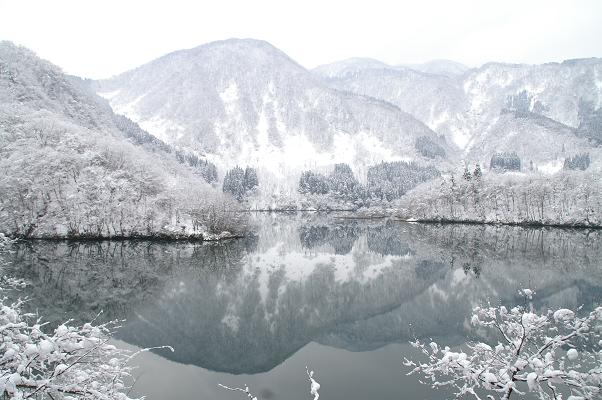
0;280;171;400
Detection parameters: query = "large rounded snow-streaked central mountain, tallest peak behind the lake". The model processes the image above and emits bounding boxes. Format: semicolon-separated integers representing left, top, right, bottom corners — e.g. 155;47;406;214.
96;39;447;180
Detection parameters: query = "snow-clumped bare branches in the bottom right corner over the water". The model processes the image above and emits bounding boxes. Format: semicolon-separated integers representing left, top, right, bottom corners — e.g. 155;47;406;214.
404;290;602;400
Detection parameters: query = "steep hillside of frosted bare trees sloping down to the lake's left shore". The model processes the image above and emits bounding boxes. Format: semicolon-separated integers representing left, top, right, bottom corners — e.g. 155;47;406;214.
0;42;241;237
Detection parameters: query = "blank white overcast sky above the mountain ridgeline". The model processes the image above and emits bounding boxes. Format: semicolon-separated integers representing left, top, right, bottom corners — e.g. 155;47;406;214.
0;0;602;78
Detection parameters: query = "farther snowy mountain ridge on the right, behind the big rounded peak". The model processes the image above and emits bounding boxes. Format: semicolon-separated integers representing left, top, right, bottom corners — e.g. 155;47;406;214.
314;58;602;164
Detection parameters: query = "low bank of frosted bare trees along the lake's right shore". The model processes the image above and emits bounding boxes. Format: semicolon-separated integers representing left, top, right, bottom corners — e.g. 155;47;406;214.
400;167;602;226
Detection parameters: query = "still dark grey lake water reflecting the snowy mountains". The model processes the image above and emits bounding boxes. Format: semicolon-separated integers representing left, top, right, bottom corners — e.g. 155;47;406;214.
1;214;602;400
